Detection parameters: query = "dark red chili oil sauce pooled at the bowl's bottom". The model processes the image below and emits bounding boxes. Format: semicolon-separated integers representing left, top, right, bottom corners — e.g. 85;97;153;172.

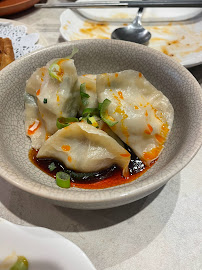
29;148;155;189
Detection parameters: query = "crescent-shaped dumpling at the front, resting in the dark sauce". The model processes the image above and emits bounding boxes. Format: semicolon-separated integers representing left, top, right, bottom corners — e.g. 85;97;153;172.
37;122;130;176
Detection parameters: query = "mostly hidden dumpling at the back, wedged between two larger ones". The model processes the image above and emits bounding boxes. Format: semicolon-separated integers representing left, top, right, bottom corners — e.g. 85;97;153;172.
79;74;98;115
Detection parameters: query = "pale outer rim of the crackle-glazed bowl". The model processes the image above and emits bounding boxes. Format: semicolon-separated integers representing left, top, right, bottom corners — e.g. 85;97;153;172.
0;39;202;209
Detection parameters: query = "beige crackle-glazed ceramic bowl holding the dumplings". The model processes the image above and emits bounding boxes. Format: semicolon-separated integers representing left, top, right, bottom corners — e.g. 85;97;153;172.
0;40;202;209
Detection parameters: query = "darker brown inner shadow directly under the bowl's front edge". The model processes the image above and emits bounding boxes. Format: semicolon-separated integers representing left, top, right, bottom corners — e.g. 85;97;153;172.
0;176;180;232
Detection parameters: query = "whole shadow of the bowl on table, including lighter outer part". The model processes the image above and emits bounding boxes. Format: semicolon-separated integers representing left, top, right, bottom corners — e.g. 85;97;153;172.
0;174;180;269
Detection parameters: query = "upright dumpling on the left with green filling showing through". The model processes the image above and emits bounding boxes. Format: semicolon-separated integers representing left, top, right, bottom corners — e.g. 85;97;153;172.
26;58;80;135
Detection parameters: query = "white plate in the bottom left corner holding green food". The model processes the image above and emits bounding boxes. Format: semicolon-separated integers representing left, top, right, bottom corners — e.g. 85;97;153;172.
0;218;95;270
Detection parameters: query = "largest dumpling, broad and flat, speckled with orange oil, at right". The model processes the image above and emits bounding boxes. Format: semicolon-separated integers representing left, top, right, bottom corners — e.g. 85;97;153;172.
96;70;174;165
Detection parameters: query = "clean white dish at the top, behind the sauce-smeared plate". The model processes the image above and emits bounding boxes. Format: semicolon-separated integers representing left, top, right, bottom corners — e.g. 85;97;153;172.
77;0;202;22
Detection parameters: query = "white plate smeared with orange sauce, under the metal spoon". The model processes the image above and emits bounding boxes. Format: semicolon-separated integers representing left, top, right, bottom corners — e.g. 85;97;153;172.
60;9;202;67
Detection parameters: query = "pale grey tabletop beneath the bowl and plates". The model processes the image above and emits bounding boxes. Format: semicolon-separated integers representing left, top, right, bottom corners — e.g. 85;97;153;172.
0;1;202;270
